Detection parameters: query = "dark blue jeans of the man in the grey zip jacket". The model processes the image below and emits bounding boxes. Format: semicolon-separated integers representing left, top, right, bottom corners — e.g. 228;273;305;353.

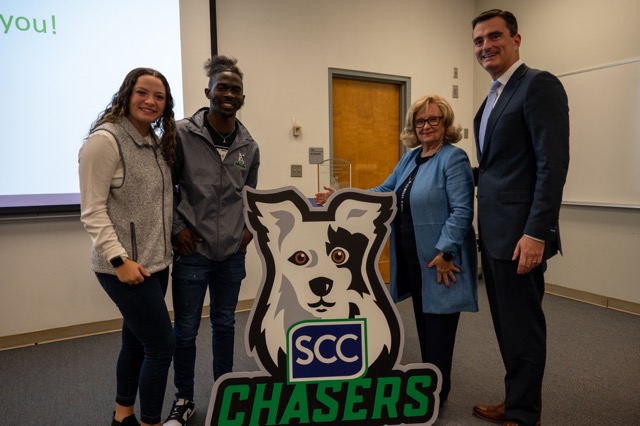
172;251;246;400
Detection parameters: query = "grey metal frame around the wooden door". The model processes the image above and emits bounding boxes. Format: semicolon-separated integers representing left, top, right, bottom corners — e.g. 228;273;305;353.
329;68;411;158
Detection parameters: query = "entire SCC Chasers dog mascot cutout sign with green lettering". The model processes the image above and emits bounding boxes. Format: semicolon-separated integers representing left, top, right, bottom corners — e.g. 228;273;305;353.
207;187;441;426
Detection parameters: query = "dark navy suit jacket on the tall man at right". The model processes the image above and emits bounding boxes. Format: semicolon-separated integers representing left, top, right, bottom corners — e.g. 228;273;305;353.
474;64;569;260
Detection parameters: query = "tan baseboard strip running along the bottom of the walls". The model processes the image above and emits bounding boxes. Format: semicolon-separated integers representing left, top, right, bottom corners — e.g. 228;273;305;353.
0;290;640;351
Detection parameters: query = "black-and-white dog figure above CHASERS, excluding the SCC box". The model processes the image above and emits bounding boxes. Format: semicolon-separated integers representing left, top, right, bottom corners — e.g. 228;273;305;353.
244;187;403;377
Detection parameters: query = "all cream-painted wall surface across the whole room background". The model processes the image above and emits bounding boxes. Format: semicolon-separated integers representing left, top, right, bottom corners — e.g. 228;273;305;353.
0;0;640;337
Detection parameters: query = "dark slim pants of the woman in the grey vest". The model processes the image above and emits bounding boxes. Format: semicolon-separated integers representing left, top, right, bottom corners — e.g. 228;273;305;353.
96;268;175;424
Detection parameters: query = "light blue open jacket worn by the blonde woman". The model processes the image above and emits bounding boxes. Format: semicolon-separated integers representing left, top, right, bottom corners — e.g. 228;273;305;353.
371;143;478;314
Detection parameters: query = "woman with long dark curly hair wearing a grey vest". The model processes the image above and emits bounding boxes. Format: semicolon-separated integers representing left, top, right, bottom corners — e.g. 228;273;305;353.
78;68;176;426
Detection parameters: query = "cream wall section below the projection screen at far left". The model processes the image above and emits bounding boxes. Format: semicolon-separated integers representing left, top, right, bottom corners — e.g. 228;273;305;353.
0;216;119;336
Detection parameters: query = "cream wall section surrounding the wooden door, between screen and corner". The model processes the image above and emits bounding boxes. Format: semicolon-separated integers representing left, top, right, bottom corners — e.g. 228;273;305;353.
212;0;473;299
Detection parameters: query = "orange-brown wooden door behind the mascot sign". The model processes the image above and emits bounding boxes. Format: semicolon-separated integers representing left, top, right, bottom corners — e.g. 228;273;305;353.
332;77;401;283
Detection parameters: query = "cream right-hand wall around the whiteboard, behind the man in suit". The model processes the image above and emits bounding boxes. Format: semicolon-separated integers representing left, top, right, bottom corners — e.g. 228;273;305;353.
469;0;640;303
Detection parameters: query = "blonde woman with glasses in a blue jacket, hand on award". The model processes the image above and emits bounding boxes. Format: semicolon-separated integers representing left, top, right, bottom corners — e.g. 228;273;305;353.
315;95;478;405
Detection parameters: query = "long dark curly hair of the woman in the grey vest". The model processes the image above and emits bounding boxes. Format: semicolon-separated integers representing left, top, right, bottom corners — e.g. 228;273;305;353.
89;68;176;166
